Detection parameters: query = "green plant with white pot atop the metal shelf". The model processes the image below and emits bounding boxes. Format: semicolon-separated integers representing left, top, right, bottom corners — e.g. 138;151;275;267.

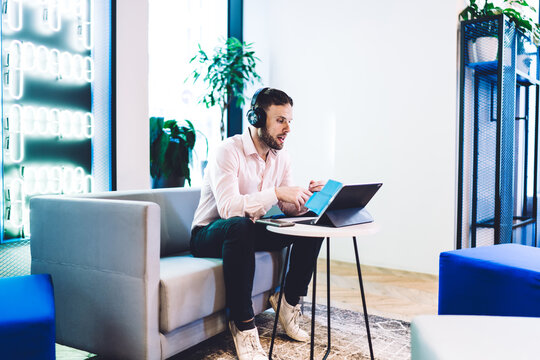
459;0;540;62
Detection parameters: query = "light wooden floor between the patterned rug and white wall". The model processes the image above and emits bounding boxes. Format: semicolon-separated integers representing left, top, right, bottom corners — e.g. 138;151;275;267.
307;259;438;321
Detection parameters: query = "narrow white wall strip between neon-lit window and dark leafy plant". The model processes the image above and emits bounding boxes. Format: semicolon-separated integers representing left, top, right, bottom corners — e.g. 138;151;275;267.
116;0;150;190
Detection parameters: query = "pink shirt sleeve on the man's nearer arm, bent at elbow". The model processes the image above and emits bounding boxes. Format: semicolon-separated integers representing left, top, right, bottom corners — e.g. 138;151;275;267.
210;144;277;220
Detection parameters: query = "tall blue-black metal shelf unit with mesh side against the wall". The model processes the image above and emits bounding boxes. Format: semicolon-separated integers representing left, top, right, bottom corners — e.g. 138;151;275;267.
456;15;540;249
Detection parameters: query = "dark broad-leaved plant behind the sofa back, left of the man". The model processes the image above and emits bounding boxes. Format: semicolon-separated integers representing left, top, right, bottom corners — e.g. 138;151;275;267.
150;117;196;188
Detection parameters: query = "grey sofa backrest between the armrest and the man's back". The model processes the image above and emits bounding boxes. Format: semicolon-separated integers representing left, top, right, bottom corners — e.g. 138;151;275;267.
85;188;201;257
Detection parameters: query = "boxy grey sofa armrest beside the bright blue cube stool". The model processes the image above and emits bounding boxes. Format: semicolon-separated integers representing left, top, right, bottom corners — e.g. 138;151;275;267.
30;196;161;359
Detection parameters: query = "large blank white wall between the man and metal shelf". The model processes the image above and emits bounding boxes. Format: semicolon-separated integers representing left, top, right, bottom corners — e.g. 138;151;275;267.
244;0;463;273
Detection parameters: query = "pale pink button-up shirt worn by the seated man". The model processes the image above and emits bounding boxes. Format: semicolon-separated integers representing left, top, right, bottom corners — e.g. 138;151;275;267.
192;131;302;228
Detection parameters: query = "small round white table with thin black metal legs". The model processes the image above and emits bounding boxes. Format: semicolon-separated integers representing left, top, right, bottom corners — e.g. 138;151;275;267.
266;222;379;360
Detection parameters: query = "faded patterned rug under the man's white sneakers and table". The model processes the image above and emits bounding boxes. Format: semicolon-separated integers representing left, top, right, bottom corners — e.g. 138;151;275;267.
57;303;410;360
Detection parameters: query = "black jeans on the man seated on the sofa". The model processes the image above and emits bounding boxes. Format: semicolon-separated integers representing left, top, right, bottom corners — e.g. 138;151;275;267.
190;217;324;321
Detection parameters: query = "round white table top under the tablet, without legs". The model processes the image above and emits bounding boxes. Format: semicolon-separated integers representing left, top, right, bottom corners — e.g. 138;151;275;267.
266;222;379;237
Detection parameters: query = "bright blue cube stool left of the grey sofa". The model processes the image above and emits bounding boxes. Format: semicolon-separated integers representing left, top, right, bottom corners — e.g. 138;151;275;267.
0;274;55;360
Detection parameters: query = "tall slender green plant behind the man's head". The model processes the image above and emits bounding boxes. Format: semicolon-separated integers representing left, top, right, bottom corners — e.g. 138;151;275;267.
186;37;261;139
